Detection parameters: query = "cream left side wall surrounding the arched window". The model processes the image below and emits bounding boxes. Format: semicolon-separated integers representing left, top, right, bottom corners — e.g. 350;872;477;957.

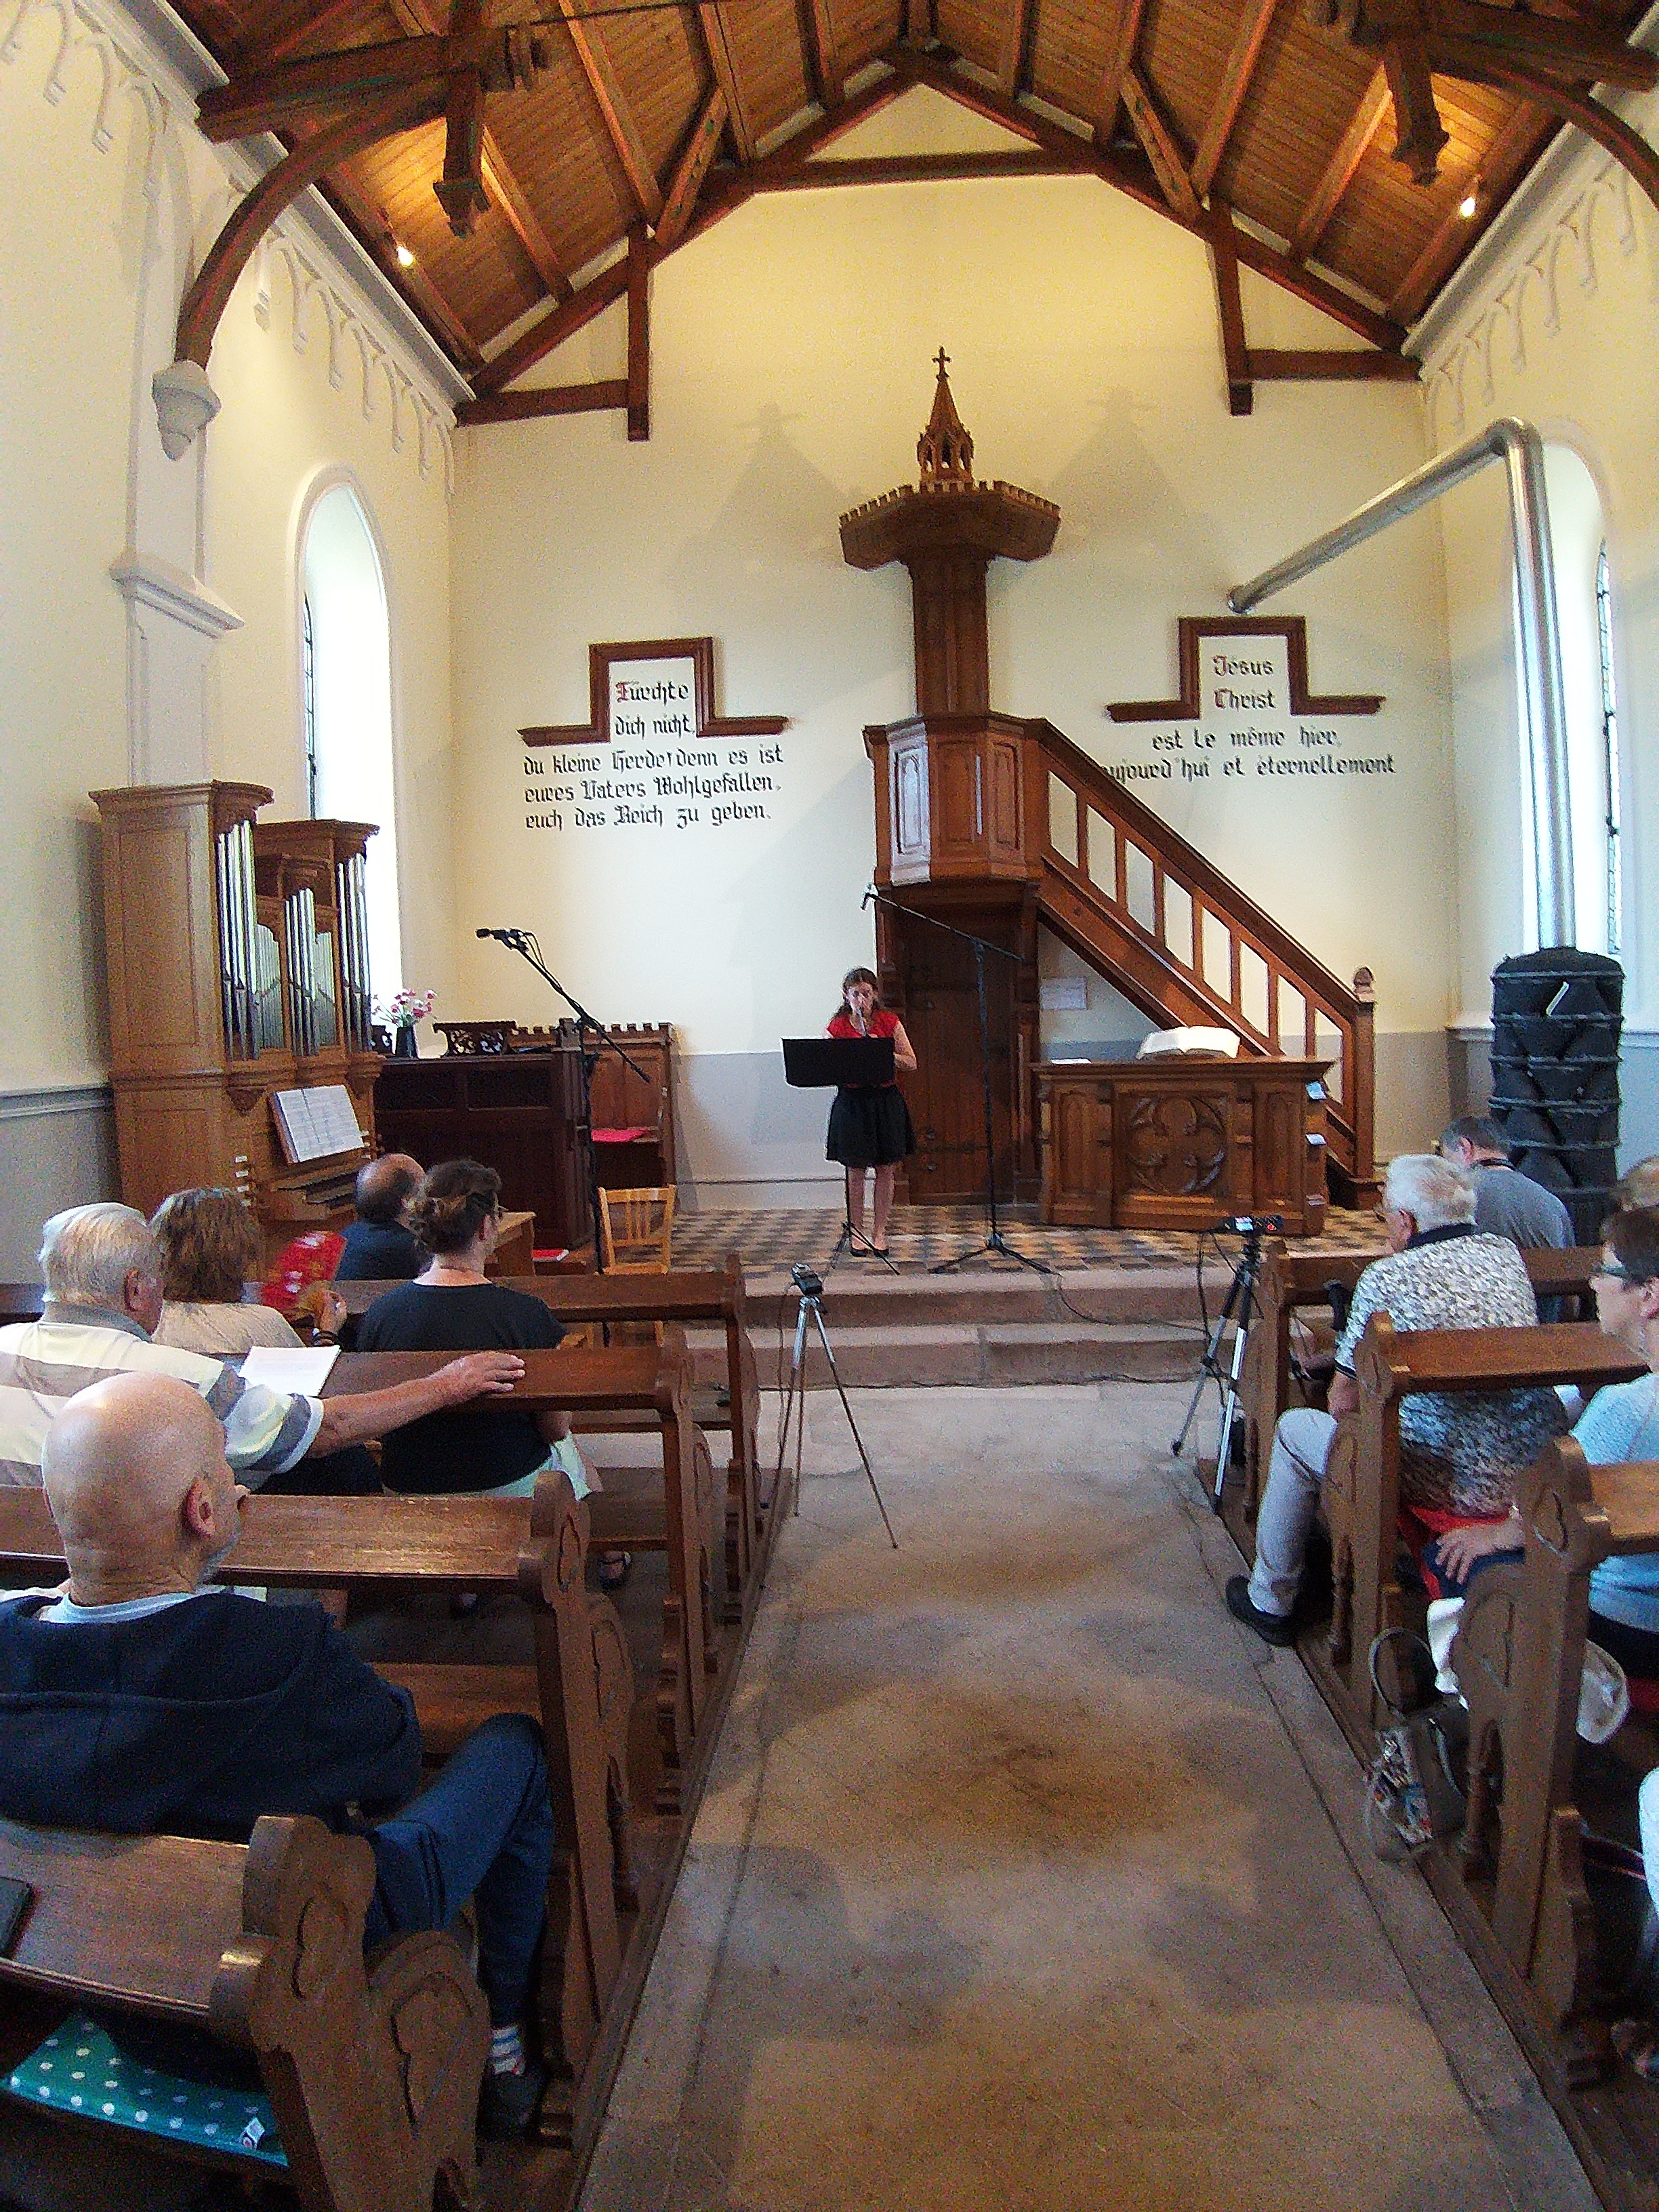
0;5;453;1111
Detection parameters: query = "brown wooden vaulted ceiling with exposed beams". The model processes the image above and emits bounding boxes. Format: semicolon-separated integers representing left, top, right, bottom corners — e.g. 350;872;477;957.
179;0;1639;394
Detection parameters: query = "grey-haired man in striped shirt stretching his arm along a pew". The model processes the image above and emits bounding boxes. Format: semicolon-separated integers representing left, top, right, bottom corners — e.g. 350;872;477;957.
0;1201;525;1491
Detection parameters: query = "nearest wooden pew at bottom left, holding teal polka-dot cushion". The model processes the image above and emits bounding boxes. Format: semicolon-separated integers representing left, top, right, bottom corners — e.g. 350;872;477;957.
0;1818;489;2212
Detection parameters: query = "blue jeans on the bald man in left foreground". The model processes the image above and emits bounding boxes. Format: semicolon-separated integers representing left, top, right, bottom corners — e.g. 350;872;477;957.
363;1712;553;2028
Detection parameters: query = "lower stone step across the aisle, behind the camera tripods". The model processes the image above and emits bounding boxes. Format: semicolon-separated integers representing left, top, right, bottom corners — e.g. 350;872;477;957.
688;1300;1201;1389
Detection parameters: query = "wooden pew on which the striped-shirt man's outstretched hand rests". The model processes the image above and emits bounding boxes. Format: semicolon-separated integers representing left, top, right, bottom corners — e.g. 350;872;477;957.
321;1330;721;1811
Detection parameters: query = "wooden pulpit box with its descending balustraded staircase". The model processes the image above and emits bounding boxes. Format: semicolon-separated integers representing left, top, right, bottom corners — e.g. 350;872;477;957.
865;712;1378;1206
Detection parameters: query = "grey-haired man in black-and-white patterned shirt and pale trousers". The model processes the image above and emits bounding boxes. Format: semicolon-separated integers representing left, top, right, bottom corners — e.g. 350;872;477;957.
1228;1153;1566;1643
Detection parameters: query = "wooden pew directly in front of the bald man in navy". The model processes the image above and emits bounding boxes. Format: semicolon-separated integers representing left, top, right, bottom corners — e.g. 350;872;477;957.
0;1473;639;2142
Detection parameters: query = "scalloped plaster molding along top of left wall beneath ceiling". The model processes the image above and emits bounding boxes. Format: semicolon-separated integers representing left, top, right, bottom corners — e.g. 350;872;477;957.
0;0;464;491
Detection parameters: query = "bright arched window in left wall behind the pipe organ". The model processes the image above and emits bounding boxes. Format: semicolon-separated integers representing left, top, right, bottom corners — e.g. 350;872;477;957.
299;485;403;998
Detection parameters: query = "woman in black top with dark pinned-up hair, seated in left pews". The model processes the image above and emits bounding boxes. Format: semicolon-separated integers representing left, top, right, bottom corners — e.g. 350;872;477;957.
356;1159;593;1498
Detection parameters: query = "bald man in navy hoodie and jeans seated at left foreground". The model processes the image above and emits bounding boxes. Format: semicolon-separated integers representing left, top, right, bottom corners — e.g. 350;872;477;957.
0;1374;553;2135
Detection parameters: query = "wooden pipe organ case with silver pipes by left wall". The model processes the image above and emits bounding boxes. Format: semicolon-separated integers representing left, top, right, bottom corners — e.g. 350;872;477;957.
93;783;380;1250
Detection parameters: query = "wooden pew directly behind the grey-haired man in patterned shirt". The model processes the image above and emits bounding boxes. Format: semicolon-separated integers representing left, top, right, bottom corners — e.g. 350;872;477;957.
1307;1314;1648;1757
